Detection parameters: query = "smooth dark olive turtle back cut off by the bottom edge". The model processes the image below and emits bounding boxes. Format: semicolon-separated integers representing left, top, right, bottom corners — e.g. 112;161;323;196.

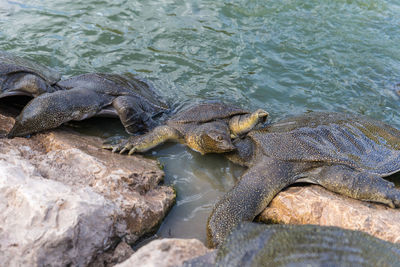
183;223;400;267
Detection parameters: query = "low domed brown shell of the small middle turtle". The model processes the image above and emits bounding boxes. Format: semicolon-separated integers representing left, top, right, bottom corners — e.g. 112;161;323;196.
169;103;250;123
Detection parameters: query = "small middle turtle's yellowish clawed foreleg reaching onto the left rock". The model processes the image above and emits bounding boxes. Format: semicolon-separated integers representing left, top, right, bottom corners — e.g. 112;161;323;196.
103;125;183;155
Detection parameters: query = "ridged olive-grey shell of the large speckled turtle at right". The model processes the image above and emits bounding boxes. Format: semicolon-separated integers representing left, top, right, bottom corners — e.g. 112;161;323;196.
248;112;400;177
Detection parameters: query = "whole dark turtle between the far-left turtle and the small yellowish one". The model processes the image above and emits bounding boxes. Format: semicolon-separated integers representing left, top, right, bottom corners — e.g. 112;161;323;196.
8;73;167;137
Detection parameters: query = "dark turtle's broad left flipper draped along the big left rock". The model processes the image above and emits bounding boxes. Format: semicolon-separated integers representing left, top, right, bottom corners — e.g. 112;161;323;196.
8;88;112;138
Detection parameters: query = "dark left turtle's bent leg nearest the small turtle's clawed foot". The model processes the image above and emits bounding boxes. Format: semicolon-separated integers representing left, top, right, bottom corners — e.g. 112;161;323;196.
112;96;157;134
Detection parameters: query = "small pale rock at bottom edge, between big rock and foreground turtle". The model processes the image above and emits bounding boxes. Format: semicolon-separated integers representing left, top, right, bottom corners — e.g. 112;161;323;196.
116;238;211;267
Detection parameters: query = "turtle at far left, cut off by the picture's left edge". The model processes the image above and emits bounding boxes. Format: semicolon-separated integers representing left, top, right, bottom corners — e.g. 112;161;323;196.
0;51;61;98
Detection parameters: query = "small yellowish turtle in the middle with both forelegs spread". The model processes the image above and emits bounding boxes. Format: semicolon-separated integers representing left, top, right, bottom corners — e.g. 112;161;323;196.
104;102;268;157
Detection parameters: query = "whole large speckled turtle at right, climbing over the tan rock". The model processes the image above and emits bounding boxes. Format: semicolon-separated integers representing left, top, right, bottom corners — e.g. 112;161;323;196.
207;112;400;246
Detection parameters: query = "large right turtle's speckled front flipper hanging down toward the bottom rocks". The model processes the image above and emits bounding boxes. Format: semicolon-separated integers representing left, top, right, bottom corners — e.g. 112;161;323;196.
207;158;292;247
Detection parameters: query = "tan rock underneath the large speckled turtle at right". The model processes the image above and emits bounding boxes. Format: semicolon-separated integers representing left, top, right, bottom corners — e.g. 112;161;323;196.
259;185;400;243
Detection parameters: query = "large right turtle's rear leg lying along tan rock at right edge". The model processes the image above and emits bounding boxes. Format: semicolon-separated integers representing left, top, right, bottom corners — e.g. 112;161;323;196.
314;165;400;208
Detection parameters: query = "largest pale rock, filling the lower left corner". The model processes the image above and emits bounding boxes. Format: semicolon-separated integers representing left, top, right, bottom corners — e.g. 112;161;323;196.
0;112;175;266
